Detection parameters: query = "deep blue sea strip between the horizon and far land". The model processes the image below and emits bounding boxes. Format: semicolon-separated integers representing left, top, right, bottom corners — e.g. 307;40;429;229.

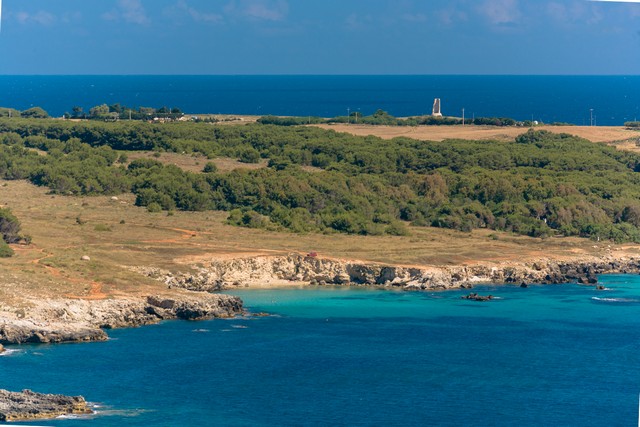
0;76;640;126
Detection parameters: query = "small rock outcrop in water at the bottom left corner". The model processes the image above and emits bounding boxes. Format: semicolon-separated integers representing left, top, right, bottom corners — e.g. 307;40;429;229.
0;390;92;421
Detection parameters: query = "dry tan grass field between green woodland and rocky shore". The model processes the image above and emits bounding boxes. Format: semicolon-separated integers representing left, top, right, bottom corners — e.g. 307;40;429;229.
0;181;640;308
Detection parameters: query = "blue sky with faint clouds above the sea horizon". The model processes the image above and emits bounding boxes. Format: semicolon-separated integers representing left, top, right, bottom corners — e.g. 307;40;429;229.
0;0;640;74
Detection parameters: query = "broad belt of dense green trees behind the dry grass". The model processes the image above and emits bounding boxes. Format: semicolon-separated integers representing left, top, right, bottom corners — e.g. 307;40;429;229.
0;119;640;242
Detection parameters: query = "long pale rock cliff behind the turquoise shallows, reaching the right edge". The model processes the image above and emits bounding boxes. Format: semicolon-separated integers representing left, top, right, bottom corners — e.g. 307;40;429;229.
136;254;640;292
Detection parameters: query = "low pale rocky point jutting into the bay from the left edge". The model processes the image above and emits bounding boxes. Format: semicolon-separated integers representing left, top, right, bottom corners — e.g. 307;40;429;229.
0;293;244;344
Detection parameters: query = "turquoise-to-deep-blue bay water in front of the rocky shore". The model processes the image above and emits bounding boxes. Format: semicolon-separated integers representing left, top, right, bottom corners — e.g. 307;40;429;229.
0;275;640;427
